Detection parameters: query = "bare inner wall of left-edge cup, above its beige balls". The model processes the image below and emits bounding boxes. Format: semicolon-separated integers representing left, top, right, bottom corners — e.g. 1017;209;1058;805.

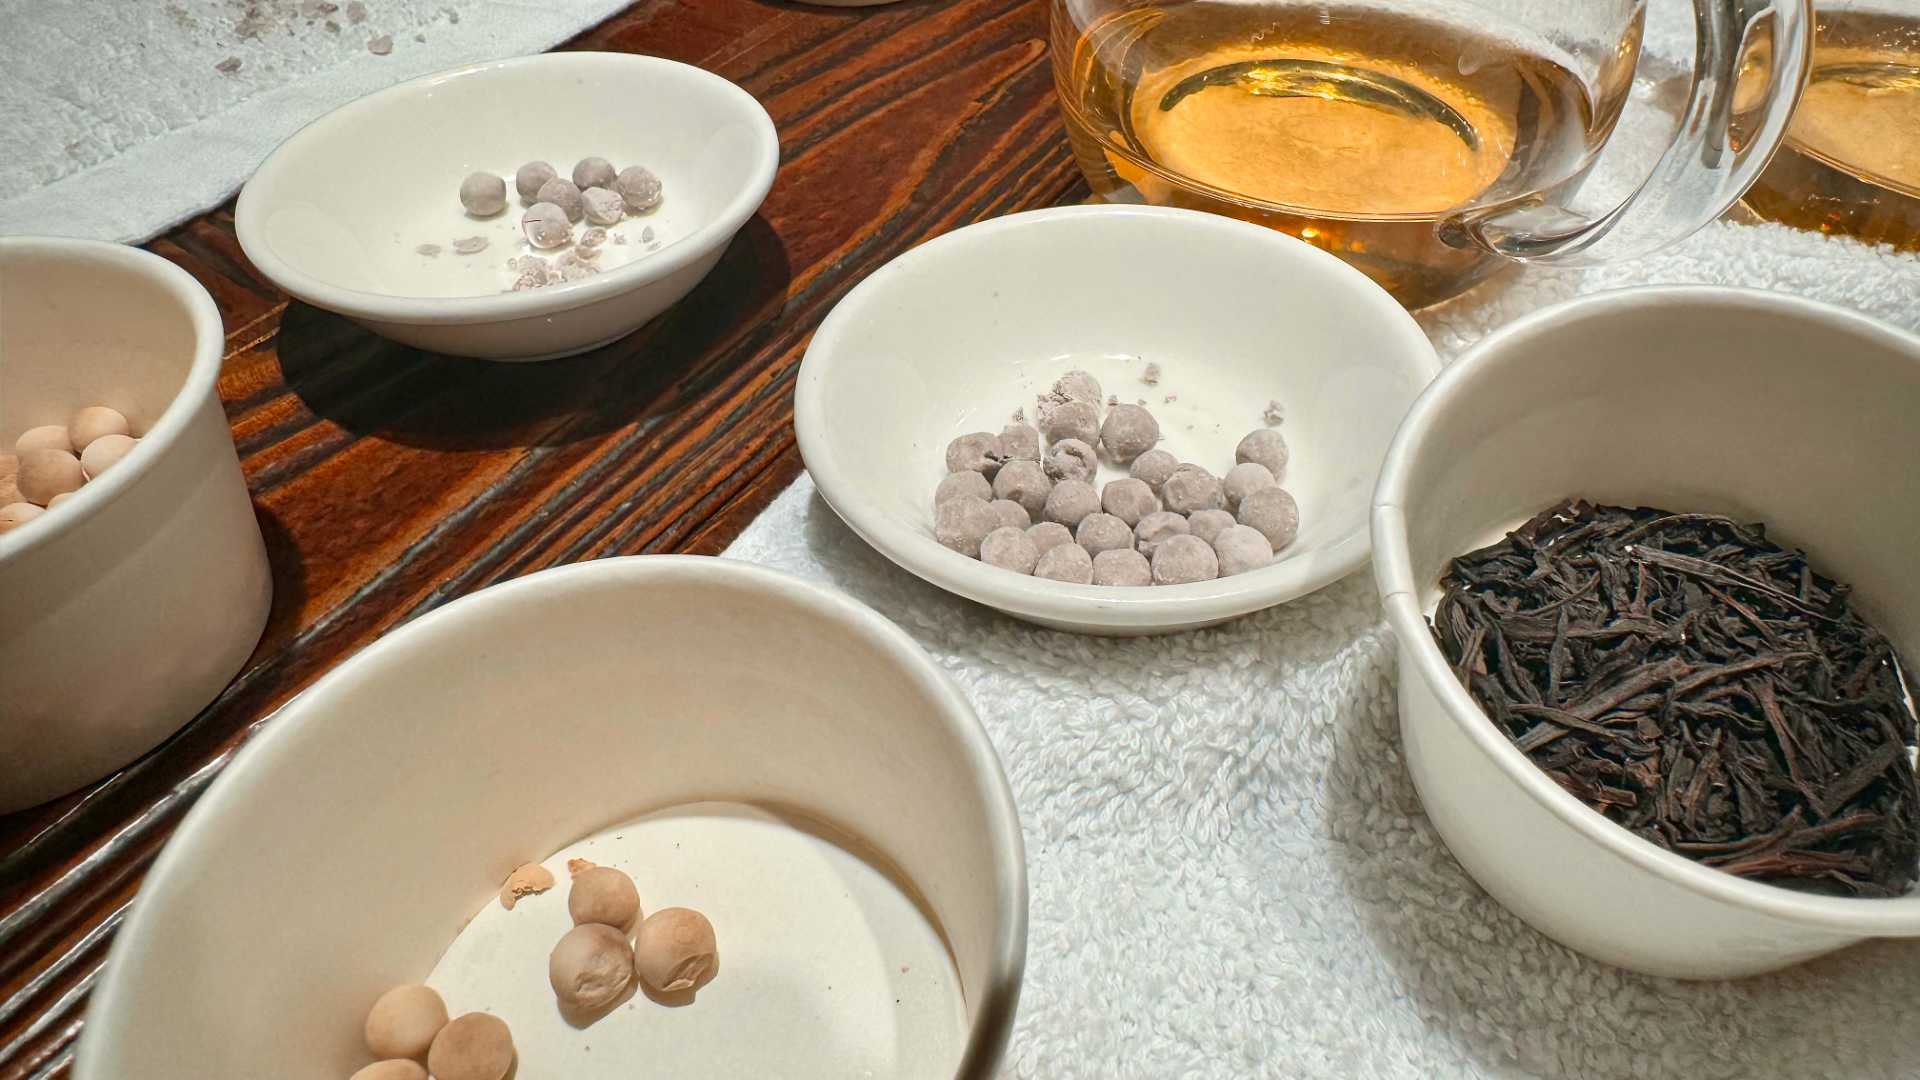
0;242;200;440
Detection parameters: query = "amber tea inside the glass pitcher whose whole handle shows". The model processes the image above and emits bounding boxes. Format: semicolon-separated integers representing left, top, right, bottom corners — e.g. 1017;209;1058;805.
1052;0;1634;307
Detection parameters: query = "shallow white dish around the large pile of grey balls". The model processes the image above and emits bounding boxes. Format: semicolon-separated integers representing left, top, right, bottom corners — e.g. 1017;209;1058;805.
793;206;1440;634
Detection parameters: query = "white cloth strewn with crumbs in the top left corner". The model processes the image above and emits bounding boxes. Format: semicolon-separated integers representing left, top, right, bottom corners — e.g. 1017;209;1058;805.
0;0;626;242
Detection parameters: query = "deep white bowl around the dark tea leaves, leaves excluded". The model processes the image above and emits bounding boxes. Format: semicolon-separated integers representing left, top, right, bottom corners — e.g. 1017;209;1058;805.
1373;286;1920;978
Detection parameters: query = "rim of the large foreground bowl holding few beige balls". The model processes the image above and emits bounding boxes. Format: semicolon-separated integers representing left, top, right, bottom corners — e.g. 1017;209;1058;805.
75;555;1029;1080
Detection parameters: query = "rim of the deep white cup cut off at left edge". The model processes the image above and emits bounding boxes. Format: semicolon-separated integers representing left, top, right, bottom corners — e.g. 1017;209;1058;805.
0;236;227;563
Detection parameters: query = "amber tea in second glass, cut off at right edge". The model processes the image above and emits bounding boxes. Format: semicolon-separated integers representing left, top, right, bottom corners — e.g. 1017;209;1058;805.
1745;12;1920;250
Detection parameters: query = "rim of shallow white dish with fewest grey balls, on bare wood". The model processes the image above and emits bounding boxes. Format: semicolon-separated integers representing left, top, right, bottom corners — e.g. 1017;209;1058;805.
234;52;780;327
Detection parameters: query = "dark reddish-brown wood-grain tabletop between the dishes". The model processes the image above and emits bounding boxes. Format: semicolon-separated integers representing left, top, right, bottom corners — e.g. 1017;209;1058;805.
0;0;1085;1080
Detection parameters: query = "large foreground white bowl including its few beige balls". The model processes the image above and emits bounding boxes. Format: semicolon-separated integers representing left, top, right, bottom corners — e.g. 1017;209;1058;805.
75;557;1027;1080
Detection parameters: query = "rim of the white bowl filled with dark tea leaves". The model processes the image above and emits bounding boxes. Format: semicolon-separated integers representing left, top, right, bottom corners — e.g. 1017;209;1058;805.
1373;284;1920;936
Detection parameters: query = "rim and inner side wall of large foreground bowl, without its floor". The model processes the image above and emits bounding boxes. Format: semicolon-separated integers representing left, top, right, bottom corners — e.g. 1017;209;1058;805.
77;557;1027;1080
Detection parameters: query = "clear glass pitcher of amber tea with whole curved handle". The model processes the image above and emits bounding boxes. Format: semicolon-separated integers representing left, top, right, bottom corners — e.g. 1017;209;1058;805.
1050;0;1812;307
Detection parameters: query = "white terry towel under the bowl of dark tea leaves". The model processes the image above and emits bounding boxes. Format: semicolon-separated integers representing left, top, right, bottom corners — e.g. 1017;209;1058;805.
728;214;1920;1080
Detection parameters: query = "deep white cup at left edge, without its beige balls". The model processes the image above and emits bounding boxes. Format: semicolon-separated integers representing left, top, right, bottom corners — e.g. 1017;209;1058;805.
0;238;273;813
